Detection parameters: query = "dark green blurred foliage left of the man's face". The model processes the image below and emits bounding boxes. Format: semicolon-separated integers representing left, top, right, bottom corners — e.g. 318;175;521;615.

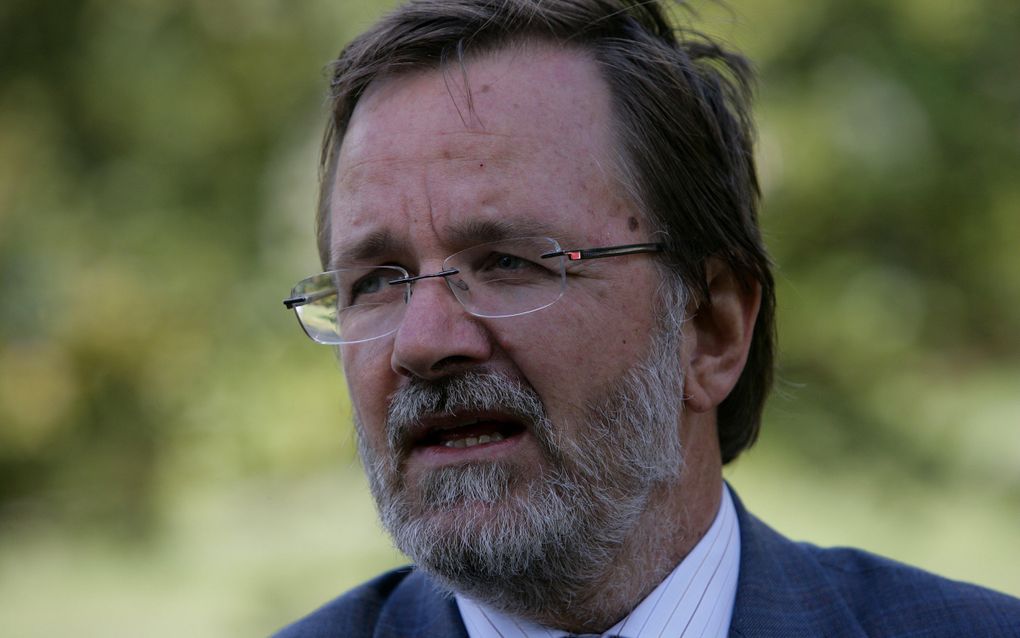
0;0;387;531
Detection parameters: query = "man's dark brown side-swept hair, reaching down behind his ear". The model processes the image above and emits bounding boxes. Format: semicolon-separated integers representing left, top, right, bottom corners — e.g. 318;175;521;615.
317;0;775;462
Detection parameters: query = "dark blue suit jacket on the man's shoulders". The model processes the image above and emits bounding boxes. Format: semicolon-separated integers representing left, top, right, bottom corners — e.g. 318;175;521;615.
276;495;1020;638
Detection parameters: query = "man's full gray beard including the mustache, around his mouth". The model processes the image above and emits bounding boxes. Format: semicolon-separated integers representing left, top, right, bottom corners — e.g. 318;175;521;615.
355;320;683;618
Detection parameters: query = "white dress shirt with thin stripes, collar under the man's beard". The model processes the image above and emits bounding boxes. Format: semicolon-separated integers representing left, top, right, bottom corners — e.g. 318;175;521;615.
457;485;741;638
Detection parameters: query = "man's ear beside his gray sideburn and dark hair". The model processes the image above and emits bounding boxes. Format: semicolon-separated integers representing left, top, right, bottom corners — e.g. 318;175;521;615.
683;257;761;412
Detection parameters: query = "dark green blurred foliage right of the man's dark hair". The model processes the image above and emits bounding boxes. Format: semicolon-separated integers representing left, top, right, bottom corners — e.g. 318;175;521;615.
749;0;1020;486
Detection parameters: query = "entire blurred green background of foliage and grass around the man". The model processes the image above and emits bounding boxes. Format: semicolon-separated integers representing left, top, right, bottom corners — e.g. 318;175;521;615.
0;0;1020;637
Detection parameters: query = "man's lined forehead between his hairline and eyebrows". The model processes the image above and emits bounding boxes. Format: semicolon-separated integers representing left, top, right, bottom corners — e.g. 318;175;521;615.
329;42;636;262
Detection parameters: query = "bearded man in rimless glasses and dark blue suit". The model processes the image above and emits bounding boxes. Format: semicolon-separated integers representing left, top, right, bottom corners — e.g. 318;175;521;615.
279;0;1020;638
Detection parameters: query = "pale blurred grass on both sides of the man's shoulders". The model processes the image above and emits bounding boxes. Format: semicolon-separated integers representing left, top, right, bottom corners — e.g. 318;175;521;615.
0;455;1020;638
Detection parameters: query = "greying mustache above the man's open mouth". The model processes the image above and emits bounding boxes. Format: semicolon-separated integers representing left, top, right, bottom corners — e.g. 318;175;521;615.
387;372;549;451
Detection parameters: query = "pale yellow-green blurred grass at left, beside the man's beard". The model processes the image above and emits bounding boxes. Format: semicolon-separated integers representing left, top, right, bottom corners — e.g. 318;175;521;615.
0;467;402;638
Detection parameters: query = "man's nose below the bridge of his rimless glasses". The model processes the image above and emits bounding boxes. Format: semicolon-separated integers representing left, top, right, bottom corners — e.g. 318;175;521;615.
391;278;493;379
